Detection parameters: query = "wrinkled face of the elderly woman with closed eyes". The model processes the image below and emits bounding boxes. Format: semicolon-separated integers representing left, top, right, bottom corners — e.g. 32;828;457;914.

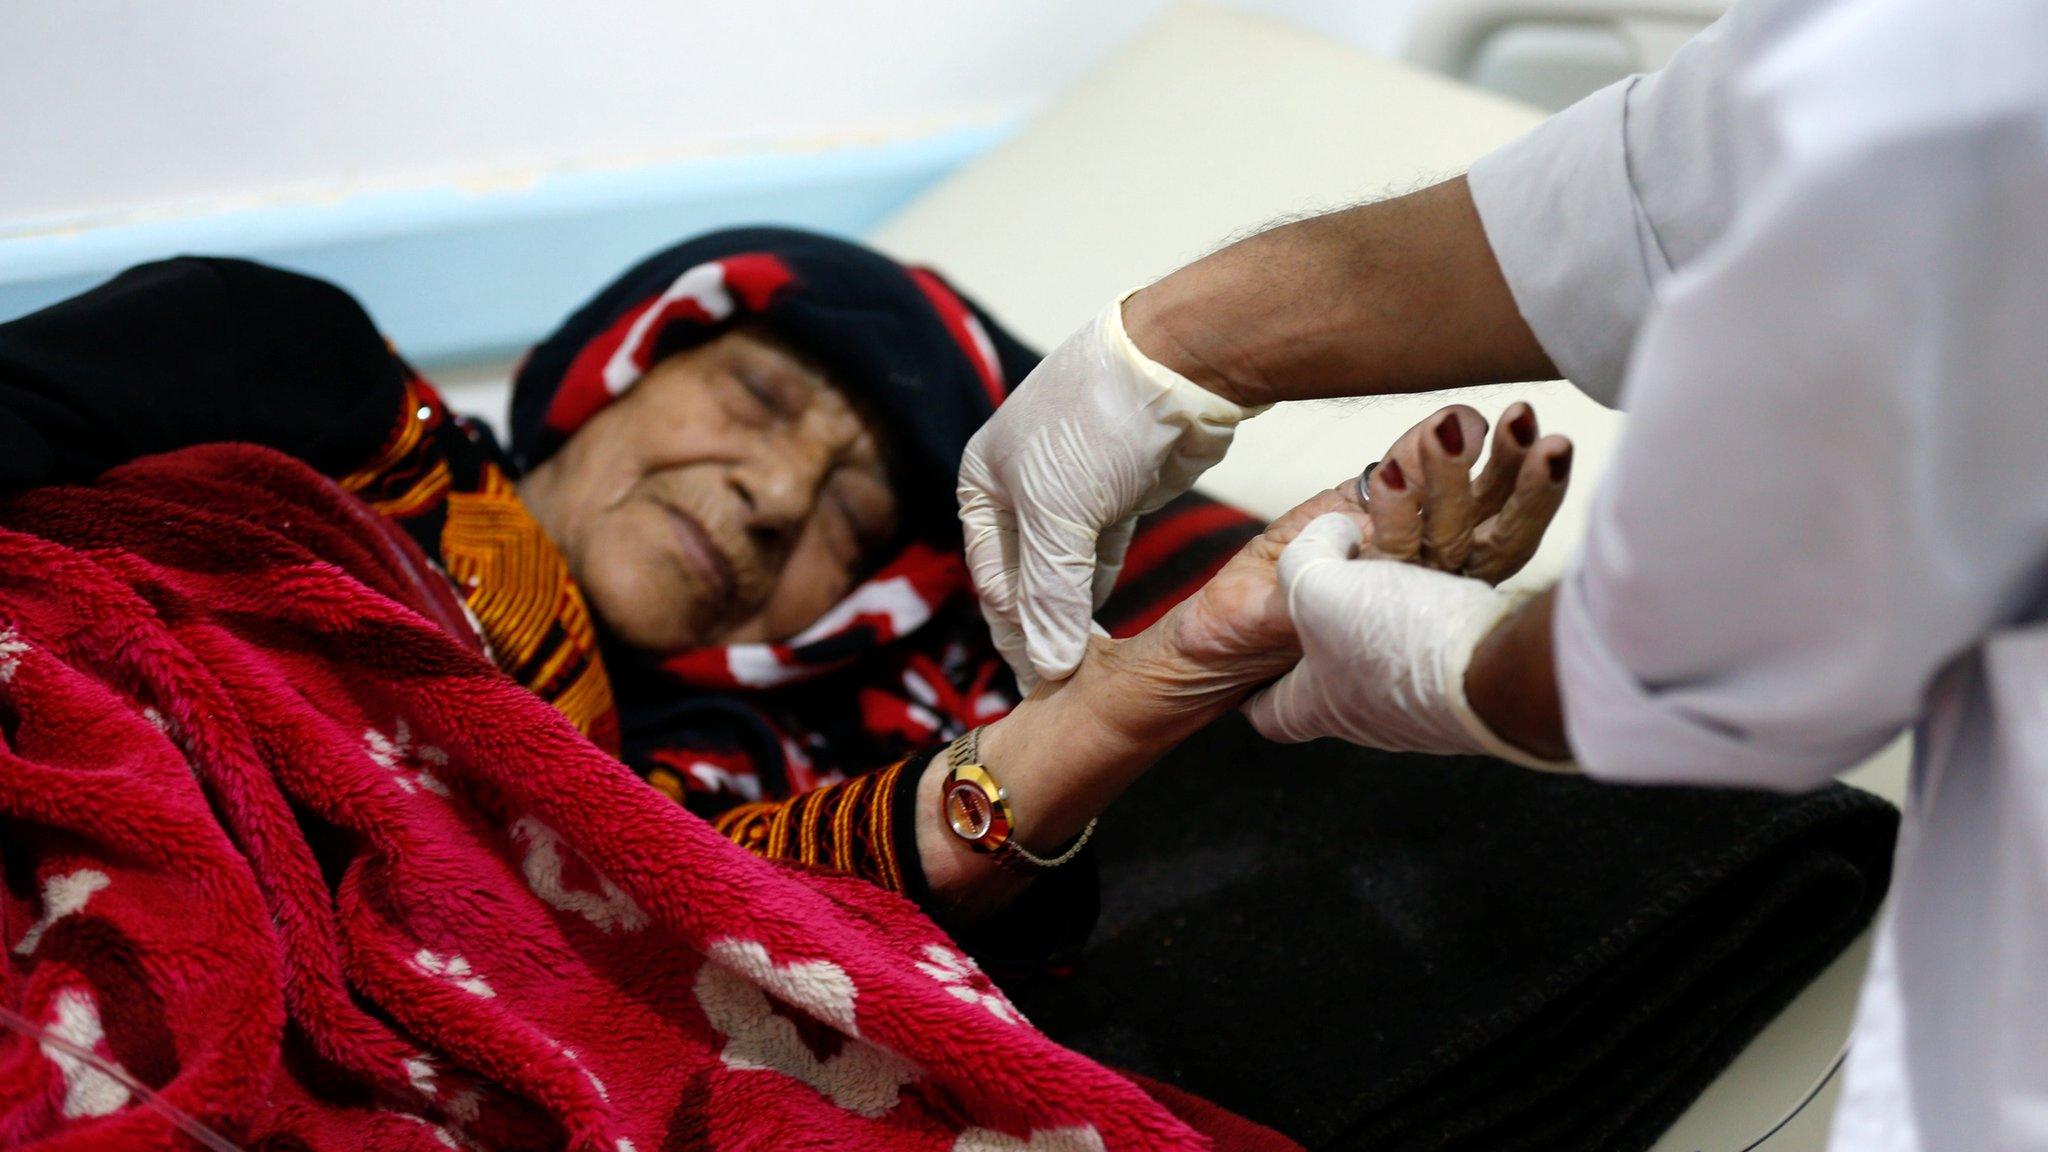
518;328;897;652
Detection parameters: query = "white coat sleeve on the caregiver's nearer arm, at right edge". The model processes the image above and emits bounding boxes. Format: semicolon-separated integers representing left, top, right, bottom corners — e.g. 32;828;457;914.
1554;118;2048;789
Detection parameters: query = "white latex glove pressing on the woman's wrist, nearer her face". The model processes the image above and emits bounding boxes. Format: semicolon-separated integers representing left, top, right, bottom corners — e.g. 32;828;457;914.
961;293;1260;689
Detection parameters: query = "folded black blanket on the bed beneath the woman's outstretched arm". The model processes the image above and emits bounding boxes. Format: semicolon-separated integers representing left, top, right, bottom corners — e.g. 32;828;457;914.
1010;717;1898;1152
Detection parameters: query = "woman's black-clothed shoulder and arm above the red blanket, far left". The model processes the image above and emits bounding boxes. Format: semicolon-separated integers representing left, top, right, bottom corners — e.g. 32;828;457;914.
0;256;406;490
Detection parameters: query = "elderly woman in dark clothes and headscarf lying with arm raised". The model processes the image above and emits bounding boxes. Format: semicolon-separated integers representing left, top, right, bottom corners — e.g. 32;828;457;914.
0;230;1569;942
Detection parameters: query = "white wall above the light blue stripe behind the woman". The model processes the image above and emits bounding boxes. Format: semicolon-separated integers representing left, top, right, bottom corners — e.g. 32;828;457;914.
0;0;1441;234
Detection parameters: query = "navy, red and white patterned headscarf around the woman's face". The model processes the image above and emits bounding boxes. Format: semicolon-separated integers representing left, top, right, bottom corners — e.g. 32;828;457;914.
512;228;1038;801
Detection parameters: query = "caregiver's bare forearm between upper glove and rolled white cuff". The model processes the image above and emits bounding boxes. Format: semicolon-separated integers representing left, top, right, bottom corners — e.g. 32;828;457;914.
1124;176;1556;404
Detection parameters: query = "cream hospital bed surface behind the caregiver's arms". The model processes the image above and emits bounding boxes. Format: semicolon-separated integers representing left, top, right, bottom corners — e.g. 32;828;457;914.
872;6;1905;1152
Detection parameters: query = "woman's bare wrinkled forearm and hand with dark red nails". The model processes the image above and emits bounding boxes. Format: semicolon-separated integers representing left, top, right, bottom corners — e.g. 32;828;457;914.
918;404;1571;920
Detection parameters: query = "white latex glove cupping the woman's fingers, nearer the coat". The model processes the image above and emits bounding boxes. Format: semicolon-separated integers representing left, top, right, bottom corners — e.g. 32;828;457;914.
1245;512;1573;771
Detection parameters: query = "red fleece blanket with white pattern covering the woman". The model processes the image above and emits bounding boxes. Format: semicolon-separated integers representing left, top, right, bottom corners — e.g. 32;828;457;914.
0;447;1261;1152
